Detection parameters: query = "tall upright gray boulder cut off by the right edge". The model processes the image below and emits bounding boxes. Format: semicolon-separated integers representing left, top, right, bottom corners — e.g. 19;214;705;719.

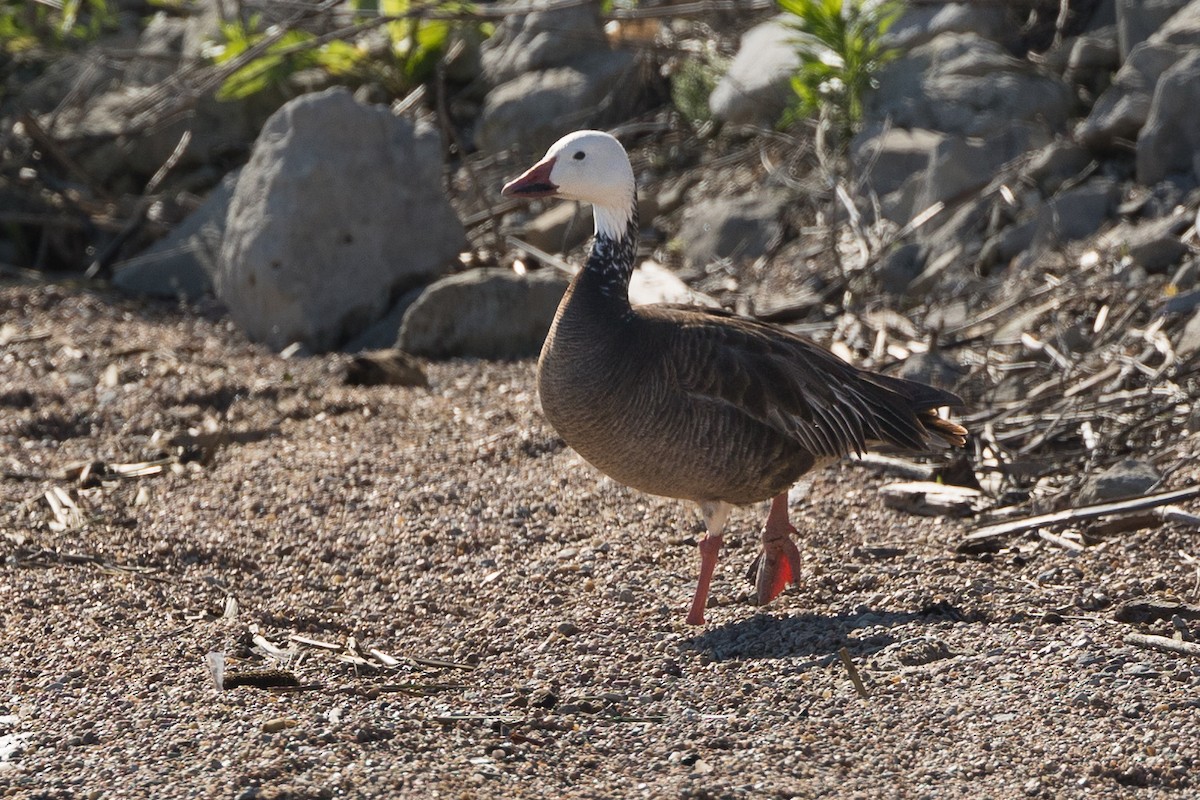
1138;50;1200;185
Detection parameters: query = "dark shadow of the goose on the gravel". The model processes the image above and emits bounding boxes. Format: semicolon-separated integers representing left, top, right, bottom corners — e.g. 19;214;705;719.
683;602;966;669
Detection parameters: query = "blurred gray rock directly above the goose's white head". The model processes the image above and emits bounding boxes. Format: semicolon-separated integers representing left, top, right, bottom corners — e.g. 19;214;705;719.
475;50;638;155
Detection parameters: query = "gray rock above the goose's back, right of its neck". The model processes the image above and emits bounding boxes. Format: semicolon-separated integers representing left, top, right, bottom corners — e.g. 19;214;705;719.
679;191;787;266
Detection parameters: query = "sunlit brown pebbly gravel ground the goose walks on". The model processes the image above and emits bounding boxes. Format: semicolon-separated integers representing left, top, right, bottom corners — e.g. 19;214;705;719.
0;285;1200;798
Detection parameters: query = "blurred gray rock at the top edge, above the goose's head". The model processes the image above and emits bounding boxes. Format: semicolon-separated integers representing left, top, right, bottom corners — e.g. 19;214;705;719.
480;0;608;86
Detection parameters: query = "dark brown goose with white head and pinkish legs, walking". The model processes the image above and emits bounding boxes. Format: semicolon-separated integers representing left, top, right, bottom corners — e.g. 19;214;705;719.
503;131;967;625
